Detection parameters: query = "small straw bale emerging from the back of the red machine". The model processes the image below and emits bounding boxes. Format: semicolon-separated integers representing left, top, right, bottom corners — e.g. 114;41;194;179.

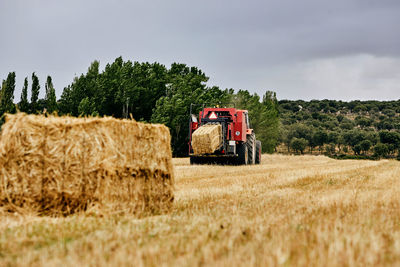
192;124;222;155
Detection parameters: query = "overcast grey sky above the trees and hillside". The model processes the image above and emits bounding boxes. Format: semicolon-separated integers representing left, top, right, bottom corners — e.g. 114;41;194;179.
0;0;400;102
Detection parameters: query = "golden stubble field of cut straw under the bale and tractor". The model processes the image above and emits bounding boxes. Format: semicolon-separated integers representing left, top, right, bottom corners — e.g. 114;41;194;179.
0;155;400;266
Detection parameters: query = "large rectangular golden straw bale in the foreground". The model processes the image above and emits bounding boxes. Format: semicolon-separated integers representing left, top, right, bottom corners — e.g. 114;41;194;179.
0;113;174;216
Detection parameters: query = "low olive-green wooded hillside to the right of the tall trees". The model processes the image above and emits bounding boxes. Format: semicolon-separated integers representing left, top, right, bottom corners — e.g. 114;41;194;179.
279;100;400;158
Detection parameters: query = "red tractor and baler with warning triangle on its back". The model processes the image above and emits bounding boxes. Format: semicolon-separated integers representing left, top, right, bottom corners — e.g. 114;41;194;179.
189;104;261;165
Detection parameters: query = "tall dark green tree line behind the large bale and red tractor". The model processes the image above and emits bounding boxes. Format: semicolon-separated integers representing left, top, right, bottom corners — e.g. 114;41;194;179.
0;57;279;156
